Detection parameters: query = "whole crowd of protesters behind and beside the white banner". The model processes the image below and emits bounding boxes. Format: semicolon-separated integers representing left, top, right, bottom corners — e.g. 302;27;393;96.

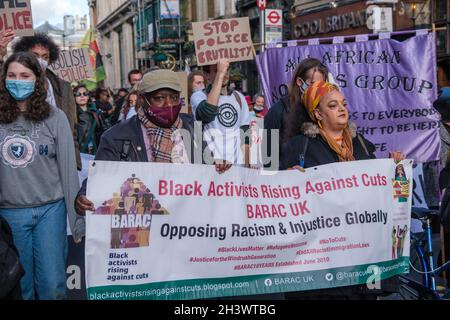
0;33;450;299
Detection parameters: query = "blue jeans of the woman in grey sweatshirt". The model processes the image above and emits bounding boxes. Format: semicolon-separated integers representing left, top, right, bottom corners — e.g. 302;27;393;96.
0;200;67;300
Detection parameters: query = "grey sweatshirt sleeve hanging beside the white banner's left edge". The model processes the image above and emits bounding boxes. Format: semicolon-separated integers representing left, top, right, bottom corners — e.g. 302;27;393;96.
55;110;85;242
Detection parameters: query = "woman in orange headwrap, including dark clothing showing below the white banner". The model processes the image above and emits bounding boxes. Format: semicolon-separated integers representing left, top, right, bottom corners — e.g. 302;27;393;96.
281;80;405;300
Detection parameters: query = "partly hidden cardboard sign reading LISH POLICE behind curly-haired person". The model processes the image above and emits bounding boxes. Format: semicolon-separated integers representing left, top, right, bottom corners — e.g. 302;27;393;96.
50;48;94;83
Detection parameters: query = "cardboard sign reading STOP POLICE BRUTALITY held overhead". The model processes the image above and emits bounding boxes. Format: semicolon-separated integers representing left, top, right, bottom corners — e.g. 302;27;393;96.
192;17;254;66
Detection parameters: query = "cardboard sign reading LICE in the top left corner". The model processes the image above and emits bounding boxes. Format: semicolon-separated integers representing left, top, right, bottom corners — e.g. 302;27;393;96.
0;0;34;37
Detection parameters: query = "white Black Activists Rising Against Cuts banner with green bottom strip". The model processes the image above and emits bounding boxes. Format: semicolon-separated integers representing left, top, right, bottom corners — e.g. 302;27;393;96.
86;159;412;300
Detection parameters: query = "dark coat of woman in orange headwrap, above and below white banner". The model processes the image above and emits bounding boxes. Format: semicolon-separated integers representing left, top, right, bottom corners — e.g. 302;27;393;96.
280;124;399;300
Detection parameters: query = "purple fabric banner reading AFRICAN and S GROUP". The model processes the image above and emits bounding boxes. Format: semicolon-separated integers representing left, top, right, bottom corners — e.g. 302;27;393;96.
256;32;440;162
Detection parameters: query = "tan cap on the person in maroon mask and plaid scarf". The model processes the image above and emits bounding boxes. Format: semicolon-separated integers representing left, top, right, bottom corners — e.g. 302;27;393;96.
137;69;181;93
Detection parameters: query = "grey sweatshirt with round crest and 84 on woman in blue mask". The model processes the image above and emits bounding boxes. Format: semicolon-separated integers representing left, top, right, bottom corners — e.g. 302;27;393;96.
0;107;85;241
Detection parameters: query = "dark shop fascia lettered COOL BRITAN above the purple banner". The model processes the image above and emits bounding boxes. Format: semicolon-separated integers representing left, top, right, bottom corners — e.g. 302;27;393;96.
291;0;432;40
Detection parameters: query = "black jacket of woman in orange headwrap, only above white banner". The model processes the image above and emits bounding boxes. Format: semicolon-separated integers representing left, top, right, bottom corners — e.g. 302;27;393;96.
280;135;376;170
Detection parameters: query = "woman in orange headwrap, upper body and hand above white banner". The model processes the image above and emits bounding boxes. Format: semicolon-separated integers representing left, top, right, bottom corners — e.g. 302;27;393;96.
281;80;404;169
